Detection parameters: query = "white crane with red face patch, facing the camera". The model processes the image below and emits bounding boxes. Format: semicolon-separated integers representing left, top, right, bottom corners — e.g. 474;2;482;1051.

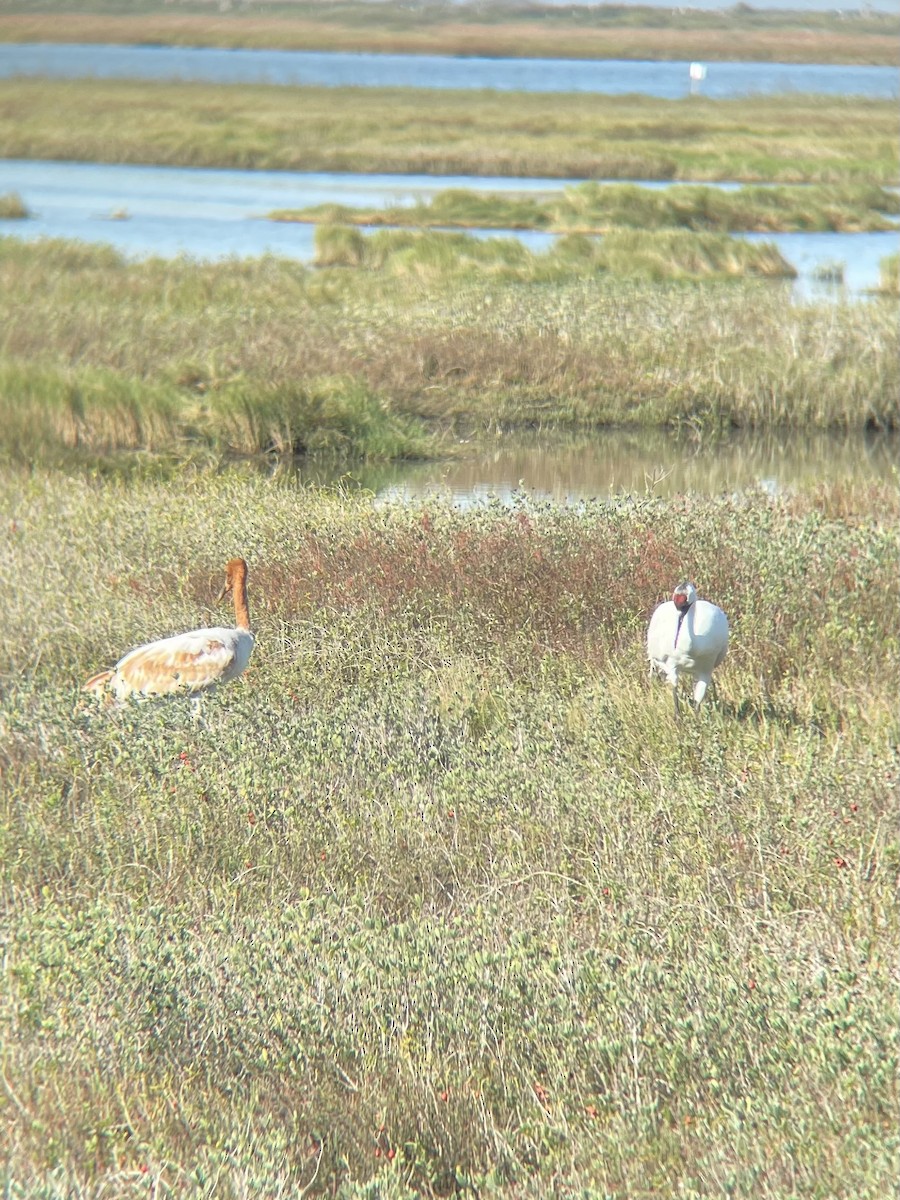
647;583;728;714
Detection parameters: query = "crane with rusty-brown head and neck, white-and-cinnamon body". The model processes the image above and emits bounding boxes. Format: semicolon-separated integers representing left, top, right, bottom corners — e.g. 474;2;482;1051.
84;558;253;701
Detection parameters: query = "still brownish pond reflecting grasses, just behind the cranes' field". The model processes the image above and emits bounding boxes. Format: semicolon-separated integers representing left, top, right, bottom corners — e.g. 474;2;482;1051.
282;430;900;505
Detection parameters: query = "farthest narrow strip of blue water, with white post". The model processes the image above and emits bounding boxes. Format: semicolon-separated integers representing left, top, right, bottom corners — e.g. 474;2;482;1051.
0;43;900;100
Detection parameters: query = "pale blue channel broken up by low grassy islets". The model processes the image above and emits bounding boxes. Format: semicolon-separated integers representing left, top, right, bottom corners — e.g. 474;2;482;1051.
0;160;900;298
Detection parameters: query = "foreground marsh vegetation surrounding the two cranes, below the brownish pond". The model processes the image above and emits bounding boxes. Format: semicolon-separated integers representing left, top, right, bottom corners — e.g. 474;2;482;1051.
0;468;900;1200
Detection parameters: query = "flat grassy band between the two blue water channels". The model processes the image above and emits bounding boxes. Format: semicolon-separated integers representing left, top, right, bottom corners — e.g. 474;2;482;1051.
0;79;896;186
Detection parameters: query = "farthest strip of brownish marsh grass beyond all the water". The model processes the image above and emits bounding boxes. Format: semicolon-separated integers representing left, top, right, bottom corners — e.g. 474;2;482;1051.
0;0;900;66
